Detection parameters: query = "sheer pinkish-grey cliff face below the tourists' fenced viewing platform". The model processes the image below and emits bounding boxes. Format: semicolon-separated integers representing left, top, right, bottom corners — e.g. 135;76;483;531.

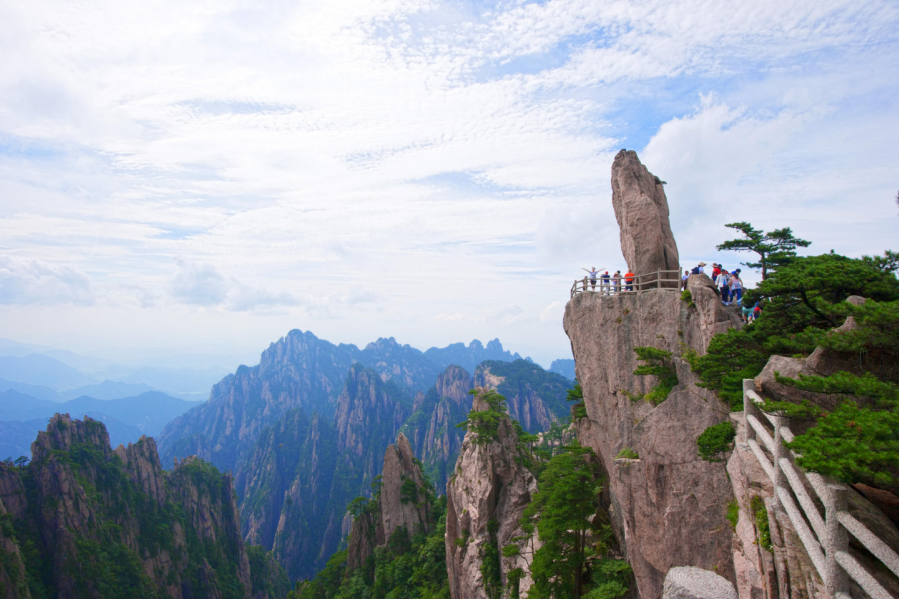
564;275;739;599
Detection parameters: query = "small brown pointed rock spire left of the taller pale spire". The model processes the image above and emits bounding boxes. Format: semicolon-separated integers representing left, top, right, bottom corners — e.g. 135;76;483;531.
347;433;434;569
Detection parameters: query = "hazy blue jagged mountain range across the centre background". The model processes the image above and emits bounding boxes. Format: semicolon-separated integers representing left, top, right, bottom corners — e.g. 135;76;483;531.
157;330;571;580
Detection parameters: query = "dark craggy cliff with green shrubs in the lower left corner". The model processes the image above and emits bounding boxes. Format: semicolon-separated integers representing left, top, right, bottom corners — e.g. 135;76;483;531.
0;415;284;598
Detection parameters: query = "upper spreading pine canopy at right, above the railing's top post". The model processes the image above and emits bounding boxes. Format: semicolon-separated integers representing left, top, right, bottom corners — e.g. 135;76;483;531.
685;254;899;410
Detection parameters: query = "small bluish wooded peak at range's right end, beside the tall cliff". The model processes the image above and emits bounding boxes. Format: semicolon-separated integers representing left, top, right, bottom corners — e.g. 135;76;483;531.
474;360;572;433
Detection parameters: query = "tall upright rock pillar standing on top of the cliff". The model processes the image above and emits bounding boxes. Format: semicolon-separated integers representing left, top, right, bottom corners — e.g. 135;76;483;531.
612;150;680;278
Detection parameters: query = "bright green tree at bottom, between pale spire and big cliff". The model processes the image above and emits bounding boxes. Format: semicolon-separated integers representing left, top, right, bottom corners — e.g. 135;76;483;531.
520;444;630;599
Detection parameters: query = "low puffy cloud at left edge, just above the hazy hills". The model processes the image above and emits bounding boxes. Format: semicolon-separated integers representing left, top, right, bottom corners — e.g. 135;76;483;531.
0;255;94;306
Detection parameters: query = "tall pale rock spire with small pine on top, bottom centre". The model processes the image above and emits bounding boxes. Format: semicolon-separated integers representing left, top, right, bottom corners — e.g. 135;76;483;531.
446;397;539;599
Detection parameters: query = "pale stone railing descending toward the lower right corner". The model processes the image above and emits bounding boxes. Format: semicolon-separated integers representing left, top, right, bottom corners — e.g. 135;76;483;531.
741;379;899;599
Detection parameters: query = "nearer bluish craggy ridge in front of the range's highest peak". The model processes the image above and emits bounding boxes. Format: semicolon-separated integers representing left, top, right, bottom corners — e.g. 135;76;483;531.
237;364;410;579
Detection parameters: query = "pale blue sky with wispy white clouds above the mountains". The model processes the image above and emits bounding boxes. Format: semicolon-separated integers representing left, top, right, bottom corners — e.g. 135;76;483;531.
0;0;899;365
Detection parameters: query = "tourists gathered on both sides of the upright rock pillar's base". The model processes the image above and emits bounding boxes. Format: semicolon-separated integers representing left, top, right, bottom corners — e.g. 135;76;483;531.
582;262;761;323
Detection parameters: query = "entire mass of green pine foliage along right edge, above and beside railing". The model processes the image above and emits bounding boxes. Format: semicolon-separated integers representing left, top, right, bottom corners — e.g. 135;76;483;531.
687;243;899;490
